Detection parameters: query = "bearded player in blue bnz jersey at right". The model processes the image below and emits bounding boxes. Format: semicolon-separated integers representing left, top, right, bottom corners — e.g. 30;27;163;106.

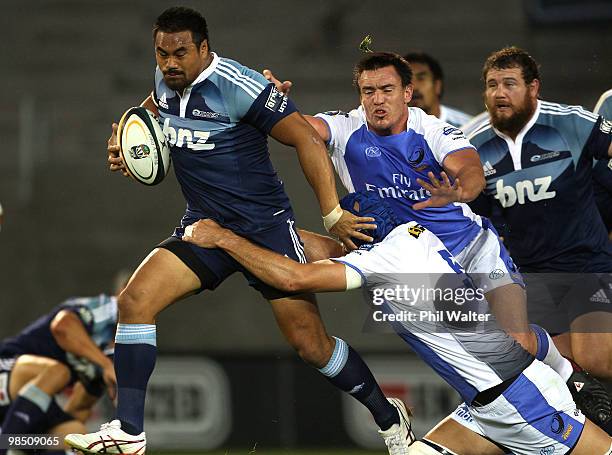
469;47;612;386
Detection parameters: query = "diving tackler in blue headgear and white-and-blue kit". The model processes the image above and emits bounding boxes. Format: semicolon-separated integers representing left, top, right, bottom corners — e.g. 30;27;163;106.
183;191;612;455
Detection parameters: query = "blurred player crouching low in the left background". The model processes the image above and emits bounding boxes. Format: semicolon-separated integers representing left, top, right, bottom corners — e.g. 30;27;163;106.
0;274;120;453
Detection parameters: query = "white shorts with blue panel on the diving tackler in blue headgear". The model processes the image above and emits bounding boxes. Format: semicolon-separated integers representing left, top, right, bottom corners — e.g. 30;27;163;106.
451;360;585;455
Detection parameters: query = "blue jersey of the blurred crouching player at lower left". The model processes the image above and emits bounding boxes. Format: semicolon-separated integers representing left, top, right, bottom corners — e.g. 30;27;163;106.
0;294;117;364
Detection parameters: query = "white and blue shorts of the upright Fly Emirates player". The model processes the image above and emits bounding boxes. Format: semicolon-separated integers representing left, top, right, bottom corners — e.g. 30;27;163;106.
455;218;525;293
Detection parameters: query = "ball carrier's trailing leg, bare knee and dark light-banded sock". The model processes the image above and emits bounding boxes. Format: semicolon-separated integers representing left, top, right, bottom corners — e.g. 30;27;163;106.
270;294;408;436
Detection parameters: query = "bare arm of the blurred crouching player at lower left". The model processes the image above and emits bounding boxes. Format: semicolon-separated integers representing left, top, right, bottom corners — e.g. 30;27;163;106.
51;310;117;399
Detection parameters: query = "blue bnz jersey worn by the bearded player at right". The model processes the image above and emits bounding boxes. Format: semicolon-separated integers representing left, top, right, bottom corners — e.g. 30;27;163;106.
468;101;612;272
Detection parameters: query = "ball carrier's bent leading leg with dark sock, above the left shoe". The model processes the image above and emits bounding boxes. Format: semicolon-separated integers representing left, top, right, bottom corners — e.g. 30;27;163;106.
114;248;201;435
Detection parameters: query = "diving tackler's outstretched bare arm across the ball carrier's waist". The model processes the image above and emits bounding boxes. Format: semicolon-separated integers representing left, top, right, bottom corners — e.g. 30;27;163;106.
183;220;346;293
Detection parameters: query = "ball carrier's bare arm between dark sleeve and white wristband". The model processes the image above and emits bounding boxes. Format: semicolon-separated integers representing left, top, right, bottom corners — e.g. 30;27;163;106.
270;112;338;215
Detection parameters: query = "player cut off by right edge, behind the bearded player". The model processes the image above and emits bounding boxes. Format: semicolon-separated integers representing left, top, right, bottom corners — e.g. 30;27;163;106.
593;89;612;236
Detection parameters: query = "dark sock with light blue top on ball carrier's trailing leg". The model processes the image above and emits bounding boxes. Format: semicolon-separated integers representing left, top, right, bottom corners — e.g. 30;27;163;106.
319;337;400;430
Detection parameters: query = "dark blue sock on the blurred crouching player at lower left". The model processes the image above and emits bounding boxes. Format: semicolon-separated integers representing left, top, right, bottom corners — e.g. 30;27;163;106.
2;384;51;434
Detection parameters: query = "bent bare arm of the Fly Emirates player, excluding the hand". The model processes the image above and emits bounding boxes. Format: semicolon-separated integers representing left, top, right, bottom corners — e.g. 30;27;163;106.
443;149;486;202
